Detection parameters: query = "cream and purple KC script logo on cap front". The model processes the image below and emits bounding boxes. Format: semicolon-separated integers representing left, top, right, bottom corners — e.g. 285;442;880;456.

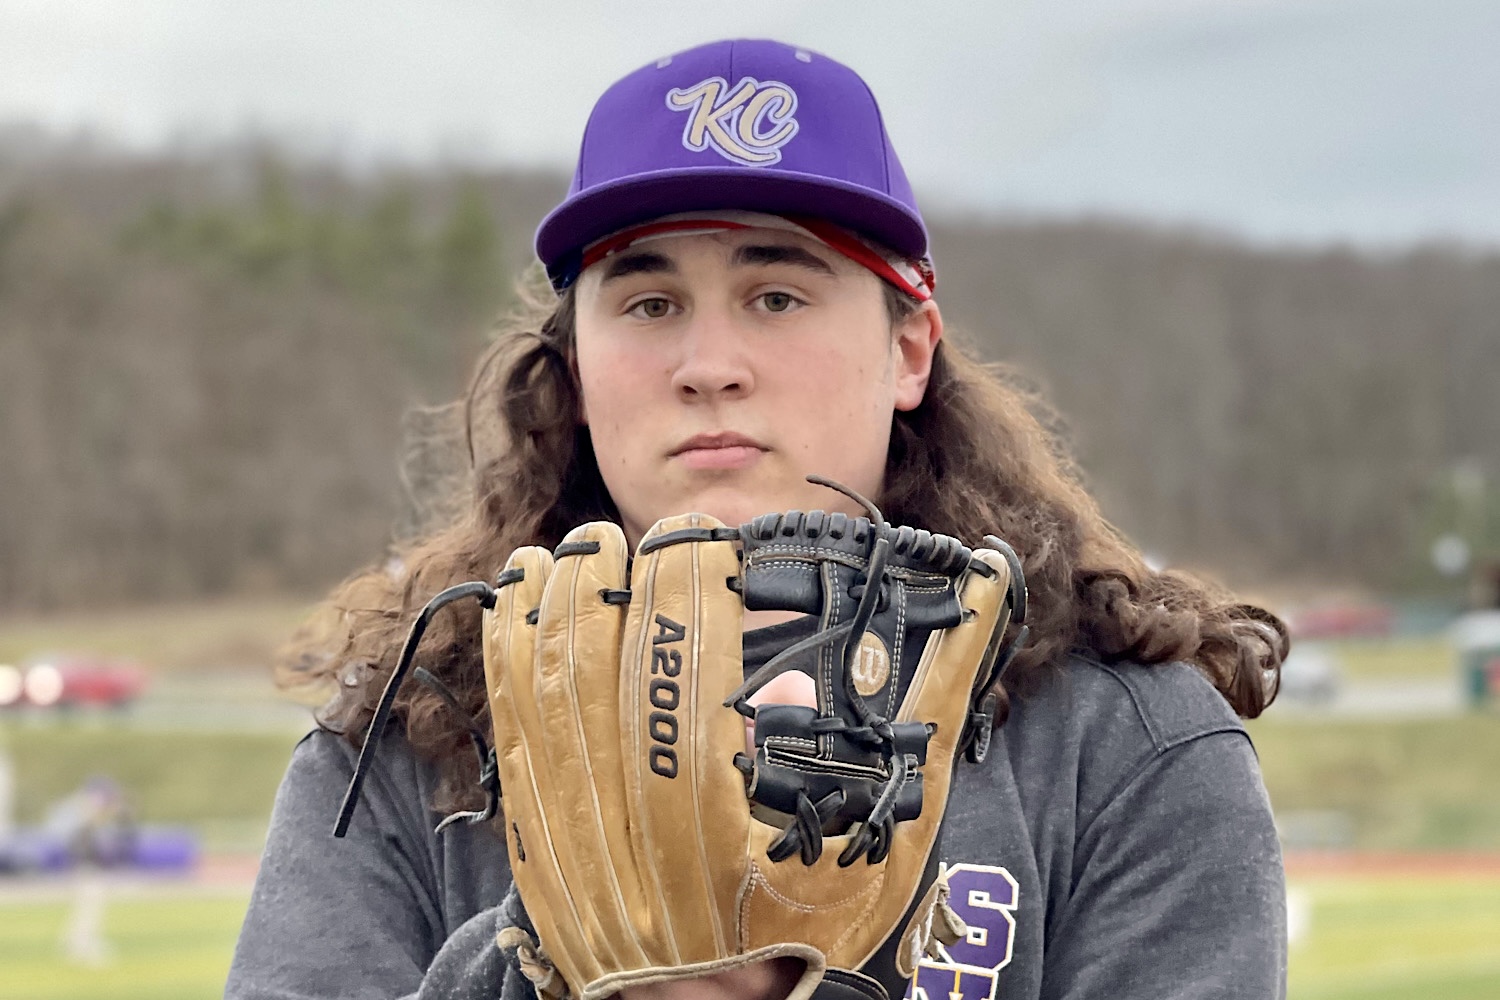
666;76;798;166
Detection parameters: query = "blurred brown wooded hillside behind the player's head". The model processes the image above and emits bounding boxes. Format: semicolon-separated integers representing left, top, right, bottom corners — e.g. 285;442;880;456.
0;142;1500;610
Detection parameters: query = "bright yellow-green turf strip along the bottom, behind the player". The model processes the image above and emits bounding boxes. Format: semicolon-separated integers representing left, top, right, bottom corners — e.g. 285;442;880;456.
0;876;1500;1000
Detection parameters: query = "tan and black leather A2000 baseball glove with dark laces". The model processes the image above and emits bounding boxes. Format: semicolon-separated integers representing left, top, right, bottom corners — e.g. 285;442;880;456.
483;479;1025;1000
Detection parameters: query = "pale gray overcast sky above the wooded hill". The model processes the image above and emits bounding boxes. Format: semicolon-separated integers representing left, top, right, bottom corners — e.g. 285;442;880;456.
0;0;1500;246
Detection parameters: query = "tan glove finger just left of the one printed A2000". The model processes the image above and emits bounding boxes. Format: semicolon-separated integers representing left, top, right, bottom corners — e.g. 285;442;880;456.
536;522;647;969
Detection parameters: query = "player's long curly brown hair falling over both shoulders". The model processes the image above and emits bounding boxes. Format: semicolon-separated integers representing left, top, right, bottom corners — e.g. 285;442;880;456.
276;268;1289;808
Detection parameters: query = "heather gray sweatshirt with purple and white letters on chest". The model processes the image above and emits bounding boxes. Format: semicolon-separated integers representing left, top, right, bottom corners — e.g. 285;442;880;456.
225;622;1286;1000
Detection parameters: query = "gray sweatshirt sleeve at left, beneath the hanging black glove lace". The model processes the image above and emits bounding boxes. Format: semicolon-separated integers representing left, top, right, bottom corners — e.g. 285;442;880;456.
225;732;515;1000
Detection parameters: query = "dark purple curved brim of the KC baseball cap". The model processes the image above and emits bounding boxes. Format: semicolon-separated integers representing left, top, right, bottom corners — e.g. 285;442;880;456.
536;166;927;277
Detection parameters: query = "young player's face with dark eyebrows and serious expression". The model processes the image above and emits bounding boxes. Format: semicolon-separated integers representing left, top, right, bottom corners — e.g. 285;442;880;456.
576;229;942;541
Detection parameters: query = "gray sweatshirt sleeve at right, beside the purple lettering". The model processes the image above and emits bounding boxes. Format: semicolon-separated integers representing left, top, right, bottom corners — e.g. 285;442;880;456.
1043;732;1287;1000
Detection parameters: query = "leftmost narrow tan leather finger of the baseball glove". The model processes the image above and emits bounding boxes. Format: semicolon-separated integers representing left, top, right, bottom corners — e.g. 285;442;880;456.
483;546;597;982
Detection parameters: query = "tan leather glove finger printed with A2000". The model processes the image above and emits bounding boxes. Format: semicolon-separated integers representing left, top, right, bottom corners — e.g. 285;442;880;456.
620;514;750;966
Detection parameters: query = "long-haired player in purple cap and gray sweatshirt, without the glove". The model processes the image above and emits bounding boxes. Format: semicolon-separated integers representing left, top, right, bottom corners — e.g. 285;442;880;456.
227;40;1286;1000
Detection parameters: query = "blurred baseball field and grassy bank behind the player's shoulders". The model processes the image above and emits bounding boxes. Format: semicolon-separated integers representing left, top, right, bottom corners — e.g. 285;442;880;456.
0;603;1500;1000
